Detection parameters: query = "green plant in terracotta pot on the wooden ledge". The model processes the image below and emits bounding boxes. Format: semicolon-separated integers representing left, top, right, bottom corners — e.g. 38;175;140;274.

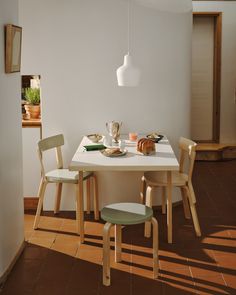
25;88;40;119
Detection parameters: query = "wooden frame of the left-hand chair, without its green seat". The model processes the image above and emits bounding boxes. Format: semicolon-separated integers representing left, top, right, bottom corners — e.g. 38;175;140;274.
33;134;99;234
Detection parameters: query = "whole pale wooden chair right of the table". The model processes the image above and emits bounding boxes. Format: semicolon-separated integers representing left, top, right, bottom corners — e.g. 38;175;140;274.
140;137;201;237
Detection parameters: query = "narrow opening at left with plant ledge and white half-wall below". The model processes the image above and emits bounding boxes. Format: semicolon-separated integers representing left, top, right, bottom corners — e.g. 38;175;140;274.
21;75;42;210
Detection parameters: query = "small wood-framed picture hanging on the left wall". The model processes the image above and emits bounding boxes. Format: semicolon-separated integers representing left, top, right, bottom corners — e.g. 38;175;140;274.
5;25;22;73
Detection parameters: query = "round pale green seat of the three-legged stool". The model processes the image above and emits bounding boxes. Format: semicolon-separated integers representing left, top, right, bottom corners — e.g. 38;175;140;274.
101;203;153;225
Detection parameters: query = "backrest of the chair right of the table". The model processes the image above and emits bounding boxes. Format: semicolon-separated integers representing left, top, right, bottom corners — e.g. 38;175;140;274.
179;137;197;181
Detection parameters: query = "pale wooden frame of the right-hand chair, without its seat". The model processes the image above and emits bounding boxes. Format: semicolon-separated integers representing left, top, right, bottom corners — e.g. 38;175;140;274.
140;137;201;237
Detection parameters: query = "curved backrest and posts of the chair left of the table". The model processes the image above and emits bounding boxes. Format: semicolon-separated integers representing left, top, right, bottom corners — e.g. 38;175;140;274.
38;134;64;177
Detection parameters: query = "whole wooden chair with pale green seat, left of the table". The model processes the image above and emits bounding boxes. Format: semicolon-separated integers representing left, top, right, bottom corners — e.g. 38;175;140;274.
33;134;99;234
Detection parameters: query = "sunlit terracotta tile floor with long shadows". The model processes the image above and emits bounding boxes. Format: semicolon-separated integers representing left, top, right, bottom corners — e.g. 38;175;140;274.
2;161;236;295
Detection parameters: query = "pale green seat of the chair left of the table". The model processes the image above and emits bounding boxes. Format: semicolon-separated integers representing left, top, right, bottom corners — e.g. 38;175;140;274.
45;169;92;184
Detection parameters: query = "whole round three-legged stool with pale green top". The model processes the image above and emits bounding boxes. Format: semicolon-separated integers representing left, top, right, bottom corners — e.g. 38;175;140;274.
101;203;159;286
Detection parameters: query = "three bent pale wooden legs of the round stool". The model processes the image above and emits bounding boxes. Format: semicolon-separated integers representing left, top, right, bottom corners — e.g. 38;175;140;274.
103;217;159;286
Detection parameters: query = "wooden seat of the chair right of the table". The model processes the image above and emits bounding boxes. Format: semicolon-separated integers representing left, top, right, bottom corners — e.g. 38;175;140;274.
144;171;188;186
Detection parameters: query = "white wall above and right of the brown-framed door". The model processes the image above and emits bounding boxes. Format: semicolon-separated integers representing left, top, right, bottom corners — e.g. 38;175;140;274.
193;1;236;143
